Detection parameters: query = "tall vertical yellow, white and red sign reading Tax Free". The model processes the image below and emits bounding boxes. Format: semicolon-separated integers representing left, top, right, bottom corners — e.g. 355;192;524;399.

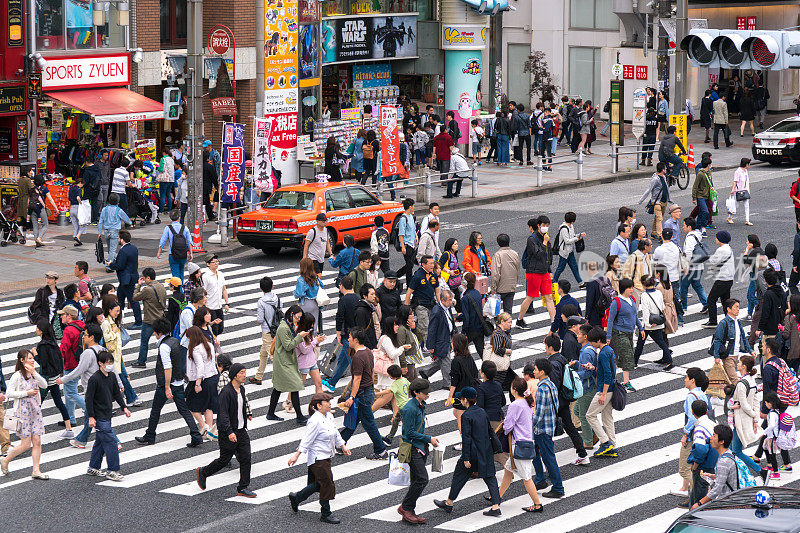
264;0;300;184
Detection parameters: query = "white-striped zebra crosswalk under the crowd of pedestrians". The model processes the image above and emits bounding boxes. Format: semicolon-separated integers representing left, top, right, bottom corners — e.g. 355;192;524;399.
0;263;800;533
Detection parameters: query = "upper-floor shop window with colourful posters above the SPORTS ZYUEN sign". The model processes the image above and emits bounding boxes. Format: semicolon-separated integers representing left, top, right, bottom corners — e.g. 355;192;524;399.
36;0;128;50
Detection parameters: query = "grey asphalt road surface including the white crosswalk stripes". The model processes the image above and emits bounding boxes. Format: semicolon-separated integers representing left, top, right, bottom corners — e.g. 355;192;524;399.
0;155;797;532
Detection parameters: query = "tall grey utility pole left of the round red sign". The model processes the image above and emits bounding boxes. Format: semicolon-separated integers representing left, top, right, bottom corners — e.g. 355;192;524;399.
186;0;204;241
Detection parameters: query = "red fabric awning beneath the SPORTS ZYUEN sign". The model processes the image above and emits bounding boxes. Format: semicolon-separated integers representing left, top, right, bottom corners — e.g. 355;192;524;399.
45;87;164;124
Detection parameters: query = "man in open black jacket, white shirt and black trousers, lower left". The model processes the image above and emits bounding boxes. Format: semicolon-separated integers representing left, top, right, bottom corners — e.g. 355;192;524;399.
195;363;256;498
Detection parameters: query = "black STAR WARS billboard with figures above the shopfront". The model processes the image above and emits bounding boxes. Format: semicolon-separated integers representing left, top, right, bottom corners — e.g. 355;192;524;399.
322;15;417;64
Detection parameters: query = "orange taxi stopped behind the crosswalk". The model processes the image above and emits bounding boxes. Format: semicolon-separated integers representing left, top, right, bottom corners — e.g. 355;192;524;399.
236;182;403;253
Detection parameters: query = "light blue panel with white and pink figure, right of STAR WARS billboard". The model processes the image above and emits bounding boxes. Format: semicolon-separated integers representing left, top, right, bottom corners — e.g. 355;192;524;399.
444;50;481;144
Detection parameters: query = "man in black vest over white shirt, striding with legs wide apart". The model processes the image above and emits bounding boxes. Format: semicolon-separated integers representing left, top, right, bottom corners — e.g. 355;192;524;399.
136;318;203;448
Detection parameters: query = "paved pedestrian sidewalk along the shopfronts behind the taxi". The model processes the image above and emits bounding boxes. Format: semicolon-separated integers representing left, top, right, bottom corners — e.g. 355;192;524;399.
0;110;791;293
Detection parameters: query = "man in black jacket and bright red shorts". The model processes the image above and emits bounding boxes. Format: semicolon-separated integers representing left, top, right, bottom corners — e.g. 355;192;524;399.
517;215;556;329
